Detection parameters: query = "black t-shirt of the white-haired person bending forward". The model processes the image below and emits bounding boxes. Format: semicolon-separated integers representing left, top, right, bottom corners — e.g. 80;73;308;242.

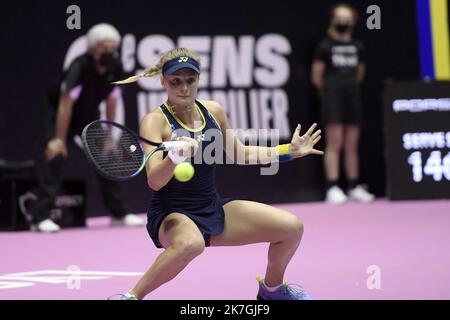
47;53;124;126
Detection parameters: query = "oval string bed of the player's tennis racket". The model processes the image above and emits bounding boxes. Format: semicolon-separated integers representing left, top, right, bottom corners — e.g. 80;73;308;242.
82;123;144;179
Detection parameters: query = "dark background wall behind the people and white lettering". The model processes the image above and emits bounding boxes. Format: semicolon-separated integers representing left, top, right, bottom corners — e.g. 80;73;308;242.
0;0;419;215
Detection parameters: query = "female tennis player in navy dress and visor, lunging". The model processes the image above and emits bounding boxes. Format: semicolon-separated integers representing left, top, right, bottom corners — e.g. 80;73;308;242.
112;48;323;300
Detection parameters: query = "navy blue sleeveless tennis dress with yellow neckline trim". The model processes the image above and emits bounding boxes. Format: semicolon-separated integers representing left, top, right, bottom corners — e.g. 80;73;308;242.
147;100;233;248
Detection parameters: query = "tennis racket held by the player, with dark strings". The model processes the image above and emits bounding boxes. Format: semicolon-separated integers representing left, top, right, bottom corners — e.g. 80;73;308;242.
81;120;186;181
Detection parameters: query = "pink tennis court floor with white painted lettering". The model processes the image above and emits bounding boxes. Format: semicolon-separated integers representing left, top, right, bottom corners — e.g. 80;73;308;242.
0;200;450;300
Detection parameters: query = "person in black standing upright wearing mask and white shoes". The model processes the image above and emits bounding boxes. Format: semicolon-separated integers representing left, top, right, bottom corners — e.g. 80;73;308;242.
311;4;374;203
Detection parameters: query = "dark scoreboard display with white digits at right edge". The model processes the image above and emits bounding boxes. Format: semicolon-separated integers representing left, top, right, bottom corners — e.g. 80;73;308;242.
384;81;450;200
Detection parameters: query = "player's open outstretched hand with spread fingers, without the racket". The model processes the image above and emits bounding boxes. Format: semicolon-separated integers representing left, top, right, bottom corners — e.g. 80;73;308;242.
289;123;323;158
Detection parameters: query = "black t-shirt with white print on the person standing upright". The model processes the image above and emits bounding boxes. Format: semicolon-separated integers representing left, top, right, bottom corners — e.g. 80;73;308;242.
314;37;365;82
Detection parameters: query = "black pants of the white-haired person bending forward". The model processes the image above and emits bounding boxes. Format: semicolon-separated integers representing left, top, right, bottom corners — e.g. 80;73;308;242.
33;96;129;223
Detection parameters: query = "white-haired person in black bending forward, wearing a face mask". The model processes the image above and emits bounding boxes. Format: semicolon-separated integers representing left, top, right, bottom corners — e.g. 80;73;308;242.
31;23;143;232
